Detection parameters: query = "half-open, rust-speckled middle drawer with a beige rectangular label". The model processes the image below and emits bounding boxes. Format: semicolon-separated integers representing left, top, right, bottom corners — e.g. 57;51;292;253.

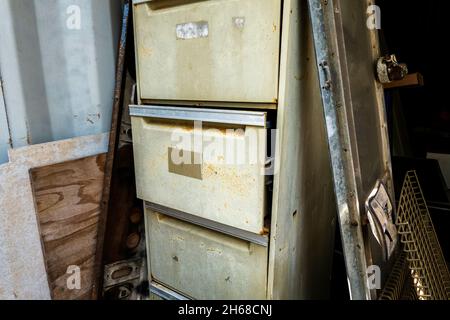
130;106;267;234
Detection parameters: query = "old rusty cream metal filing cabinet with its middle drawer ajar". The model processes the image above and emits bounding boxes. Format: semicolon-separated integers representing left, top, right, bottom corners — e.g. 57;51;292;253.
130;0;335;299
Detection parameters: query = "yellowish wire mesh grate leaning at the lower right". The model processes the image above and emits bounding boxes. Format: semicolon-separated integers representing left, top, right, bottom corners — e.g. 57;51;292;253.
388;171;450;300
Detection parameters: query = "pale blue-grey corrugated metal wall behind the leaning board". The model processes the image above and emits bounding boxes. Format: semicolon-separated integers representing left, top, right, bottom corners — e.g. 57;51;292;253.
0;0;121;163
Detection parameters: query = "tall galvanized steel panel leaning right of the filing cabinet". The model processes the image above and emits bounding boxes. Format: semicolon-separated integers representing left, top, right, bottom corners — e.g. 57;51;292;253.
309;0;393;300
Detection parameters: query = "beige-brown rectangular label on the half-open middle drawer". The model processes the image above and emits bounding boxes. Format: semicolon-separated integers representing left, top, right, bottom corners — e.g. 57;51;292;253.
168;148;203;180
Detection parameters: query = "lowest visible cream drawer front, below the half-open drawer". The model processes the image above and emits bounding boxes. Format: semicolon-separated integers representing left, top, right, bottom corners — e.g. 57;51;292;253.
146;210;268;300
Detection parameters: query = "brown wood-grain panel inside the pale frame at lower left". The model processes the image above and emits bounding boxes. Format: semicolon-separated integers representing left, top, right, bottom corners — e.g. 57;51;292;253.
30;154;106;300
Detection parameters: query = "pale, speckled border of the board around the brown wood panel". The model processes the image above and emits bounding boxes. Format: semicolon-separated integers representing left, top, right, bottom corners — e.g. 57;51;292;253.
0;134;108;300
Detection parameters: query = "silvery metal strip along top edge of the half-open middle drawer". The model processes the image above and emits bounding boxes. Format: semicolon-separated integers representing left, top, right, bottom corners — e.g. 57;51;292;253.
130;105;267;127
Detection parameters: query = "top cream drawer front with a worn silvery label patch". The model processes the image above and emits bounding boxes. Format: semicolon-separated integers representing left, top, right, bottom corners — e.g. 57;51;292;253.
134;0;281;103
